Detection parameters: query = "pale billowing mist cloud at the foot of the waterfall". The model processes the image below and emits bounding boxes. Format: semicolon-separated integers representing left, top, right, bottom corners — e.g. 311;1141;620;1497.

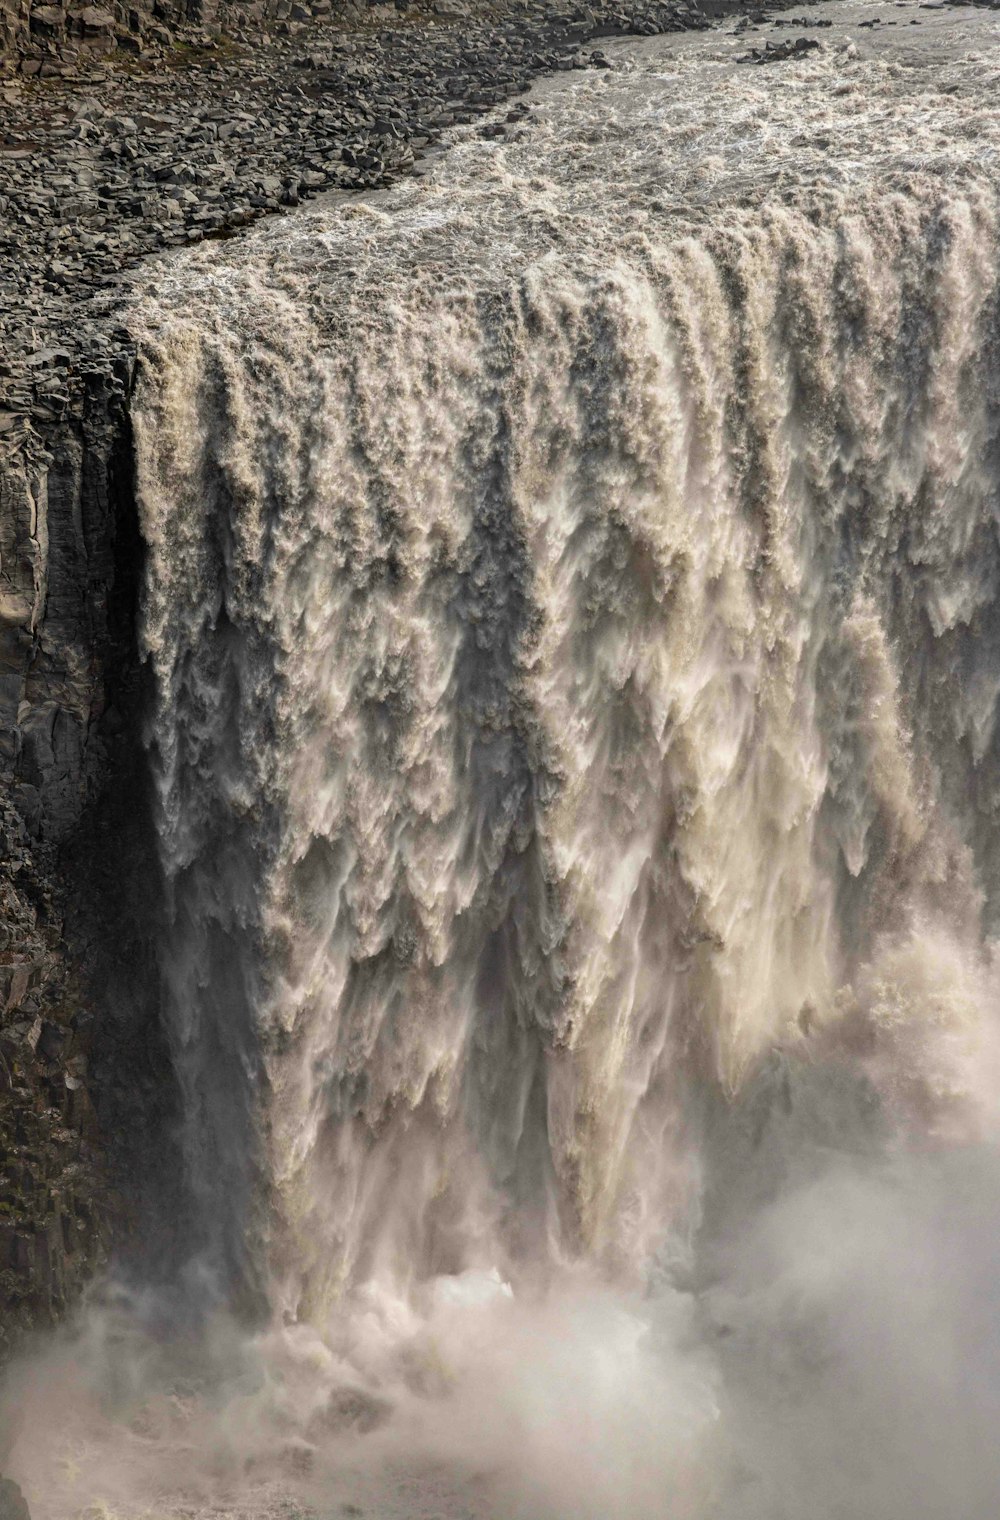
2;1110;1000;1520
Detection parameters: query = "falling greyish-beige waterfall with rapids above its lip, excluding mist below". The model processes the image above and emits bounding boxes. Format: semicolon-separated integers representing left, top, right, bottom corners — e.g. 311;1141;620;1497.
128;32;1000;1319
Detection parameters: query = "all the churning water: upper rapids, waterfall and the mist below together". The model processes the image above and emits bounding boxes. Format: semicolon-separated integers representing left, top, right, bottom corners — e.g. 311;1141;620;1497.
9;5;1000;1520
